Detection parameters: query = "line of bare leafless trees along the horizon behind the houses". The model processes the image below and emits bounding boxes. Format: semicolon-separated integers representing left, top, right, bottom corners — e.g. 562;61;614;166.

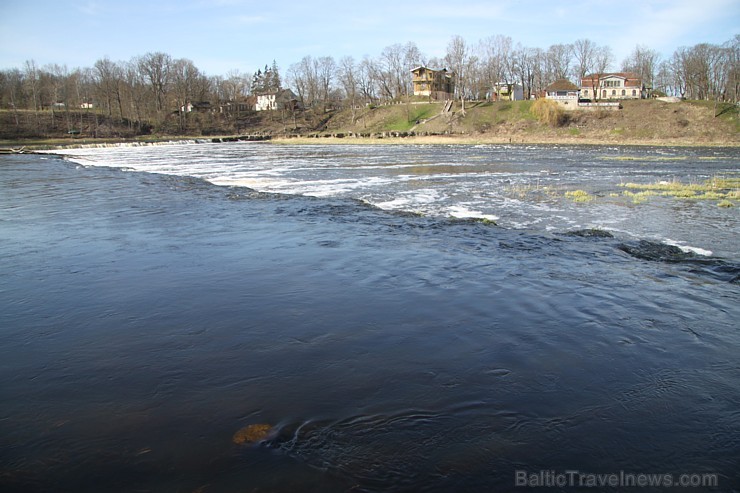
0;35;740;130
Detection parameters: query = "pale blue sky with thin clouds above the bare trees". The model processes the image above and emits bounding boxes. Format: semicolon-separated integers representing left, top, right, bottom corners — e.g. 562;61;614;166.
0;0;740;76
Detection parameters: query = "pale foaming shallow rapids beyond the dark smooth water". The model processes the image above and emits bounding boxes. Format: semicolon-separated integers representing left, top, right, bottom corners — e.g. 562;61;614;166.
55;143;740;256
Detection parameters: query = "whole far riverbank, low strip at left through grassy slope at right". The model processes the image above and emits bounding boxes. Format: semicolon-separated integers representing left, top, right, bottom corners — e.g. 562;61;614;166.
0;100;740;150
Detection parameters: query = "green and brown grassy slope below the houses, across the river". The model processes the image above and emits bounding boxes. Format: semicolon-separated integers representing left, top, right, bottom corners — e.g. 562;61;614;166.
280;100;740;146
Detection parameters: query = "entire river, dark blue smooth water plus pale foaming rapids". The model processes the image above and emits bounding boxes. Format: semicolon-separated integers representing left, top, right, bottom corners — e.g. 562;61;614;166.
0;143;740;492
